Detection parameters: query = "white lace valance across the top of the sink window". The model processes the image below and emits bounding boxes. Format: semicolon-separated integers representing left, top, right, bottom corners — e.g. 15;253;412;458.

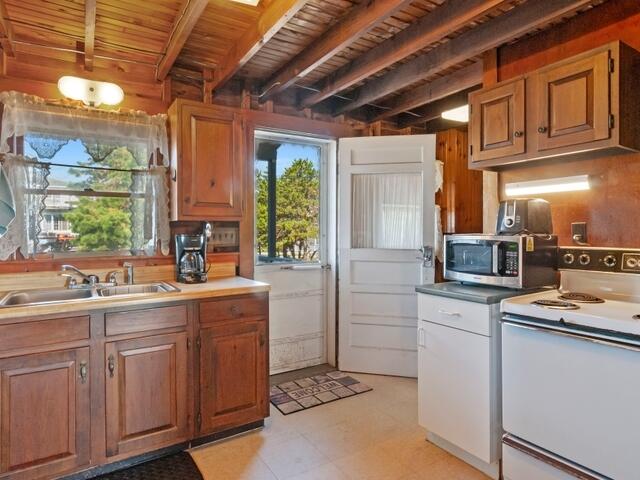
0;92;169;167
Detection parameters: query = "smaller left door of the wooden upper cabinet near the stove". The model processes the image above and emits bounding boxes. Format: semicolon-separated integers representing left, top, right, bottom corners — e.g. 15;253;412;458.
469;79;525;162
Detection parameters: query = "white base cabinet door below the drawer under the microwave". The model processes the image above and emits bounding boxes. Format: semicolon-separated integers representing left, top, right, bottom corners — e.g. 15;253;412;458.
420;321;495;463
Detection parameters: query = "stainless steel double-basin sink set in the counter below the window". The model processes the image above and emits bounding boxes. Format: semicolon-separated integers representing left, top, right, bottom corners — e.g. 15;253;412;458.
0;282;180;307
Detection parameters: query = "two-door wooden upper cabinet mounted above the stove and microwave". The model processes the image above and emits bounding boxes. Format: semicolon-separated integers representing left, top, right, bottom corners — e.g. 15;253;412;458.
469;42;640;169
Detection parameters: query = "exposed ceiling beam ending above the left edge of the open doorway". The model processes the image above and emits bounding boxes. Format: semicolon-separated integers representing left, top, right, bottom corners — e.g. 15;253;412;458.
260;0;411;102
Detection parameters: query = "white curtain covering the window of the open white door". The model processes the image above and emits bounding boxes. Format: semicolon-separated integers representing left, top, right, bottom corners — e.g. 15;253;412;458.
351;173;422;250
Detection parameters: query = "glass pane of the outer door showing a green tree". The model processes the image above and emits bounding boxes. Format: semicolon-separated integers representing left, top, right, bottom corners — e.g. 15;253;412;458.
255;138;322;263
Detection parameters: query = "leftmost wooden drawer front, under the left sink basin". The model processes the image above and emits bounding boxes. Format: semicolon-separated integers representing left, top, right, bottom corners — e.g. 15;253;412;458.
0;316;89;351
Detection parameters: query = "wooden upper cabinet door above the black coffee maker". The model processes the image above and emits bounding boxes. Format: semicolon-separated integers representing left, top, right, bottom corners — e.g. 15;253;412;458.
178;105;243;218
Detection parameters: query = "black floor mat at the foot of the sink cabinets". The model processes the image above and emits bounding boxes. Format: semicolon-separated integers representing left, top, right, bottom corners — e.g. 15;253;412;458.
95;452;204;480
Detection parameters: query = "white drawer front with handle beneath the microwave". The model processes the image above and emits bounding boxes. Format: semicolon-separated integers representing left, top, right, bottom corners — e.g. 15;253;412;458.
418;294;492;337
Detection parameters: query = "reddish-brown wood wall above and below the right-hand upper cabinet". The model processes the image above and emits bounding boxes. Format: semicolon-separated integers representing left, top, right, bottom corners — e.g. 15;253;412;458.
498;0;640;248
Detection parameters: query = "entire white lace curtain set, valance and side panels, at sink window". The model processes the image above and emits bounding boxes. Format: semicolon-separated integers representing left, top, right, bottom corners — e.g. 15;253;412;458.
0;92;170;260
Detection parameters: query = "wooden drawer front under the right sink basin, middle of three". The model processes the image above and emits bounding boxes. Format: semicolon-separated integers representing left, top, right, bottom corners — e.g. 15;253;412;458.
104;305;187;335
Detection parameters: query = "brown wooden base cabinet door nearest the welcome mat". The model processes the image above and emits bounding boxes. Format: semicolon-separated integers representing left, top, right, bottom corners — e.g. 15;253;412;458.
200;320;269;434
